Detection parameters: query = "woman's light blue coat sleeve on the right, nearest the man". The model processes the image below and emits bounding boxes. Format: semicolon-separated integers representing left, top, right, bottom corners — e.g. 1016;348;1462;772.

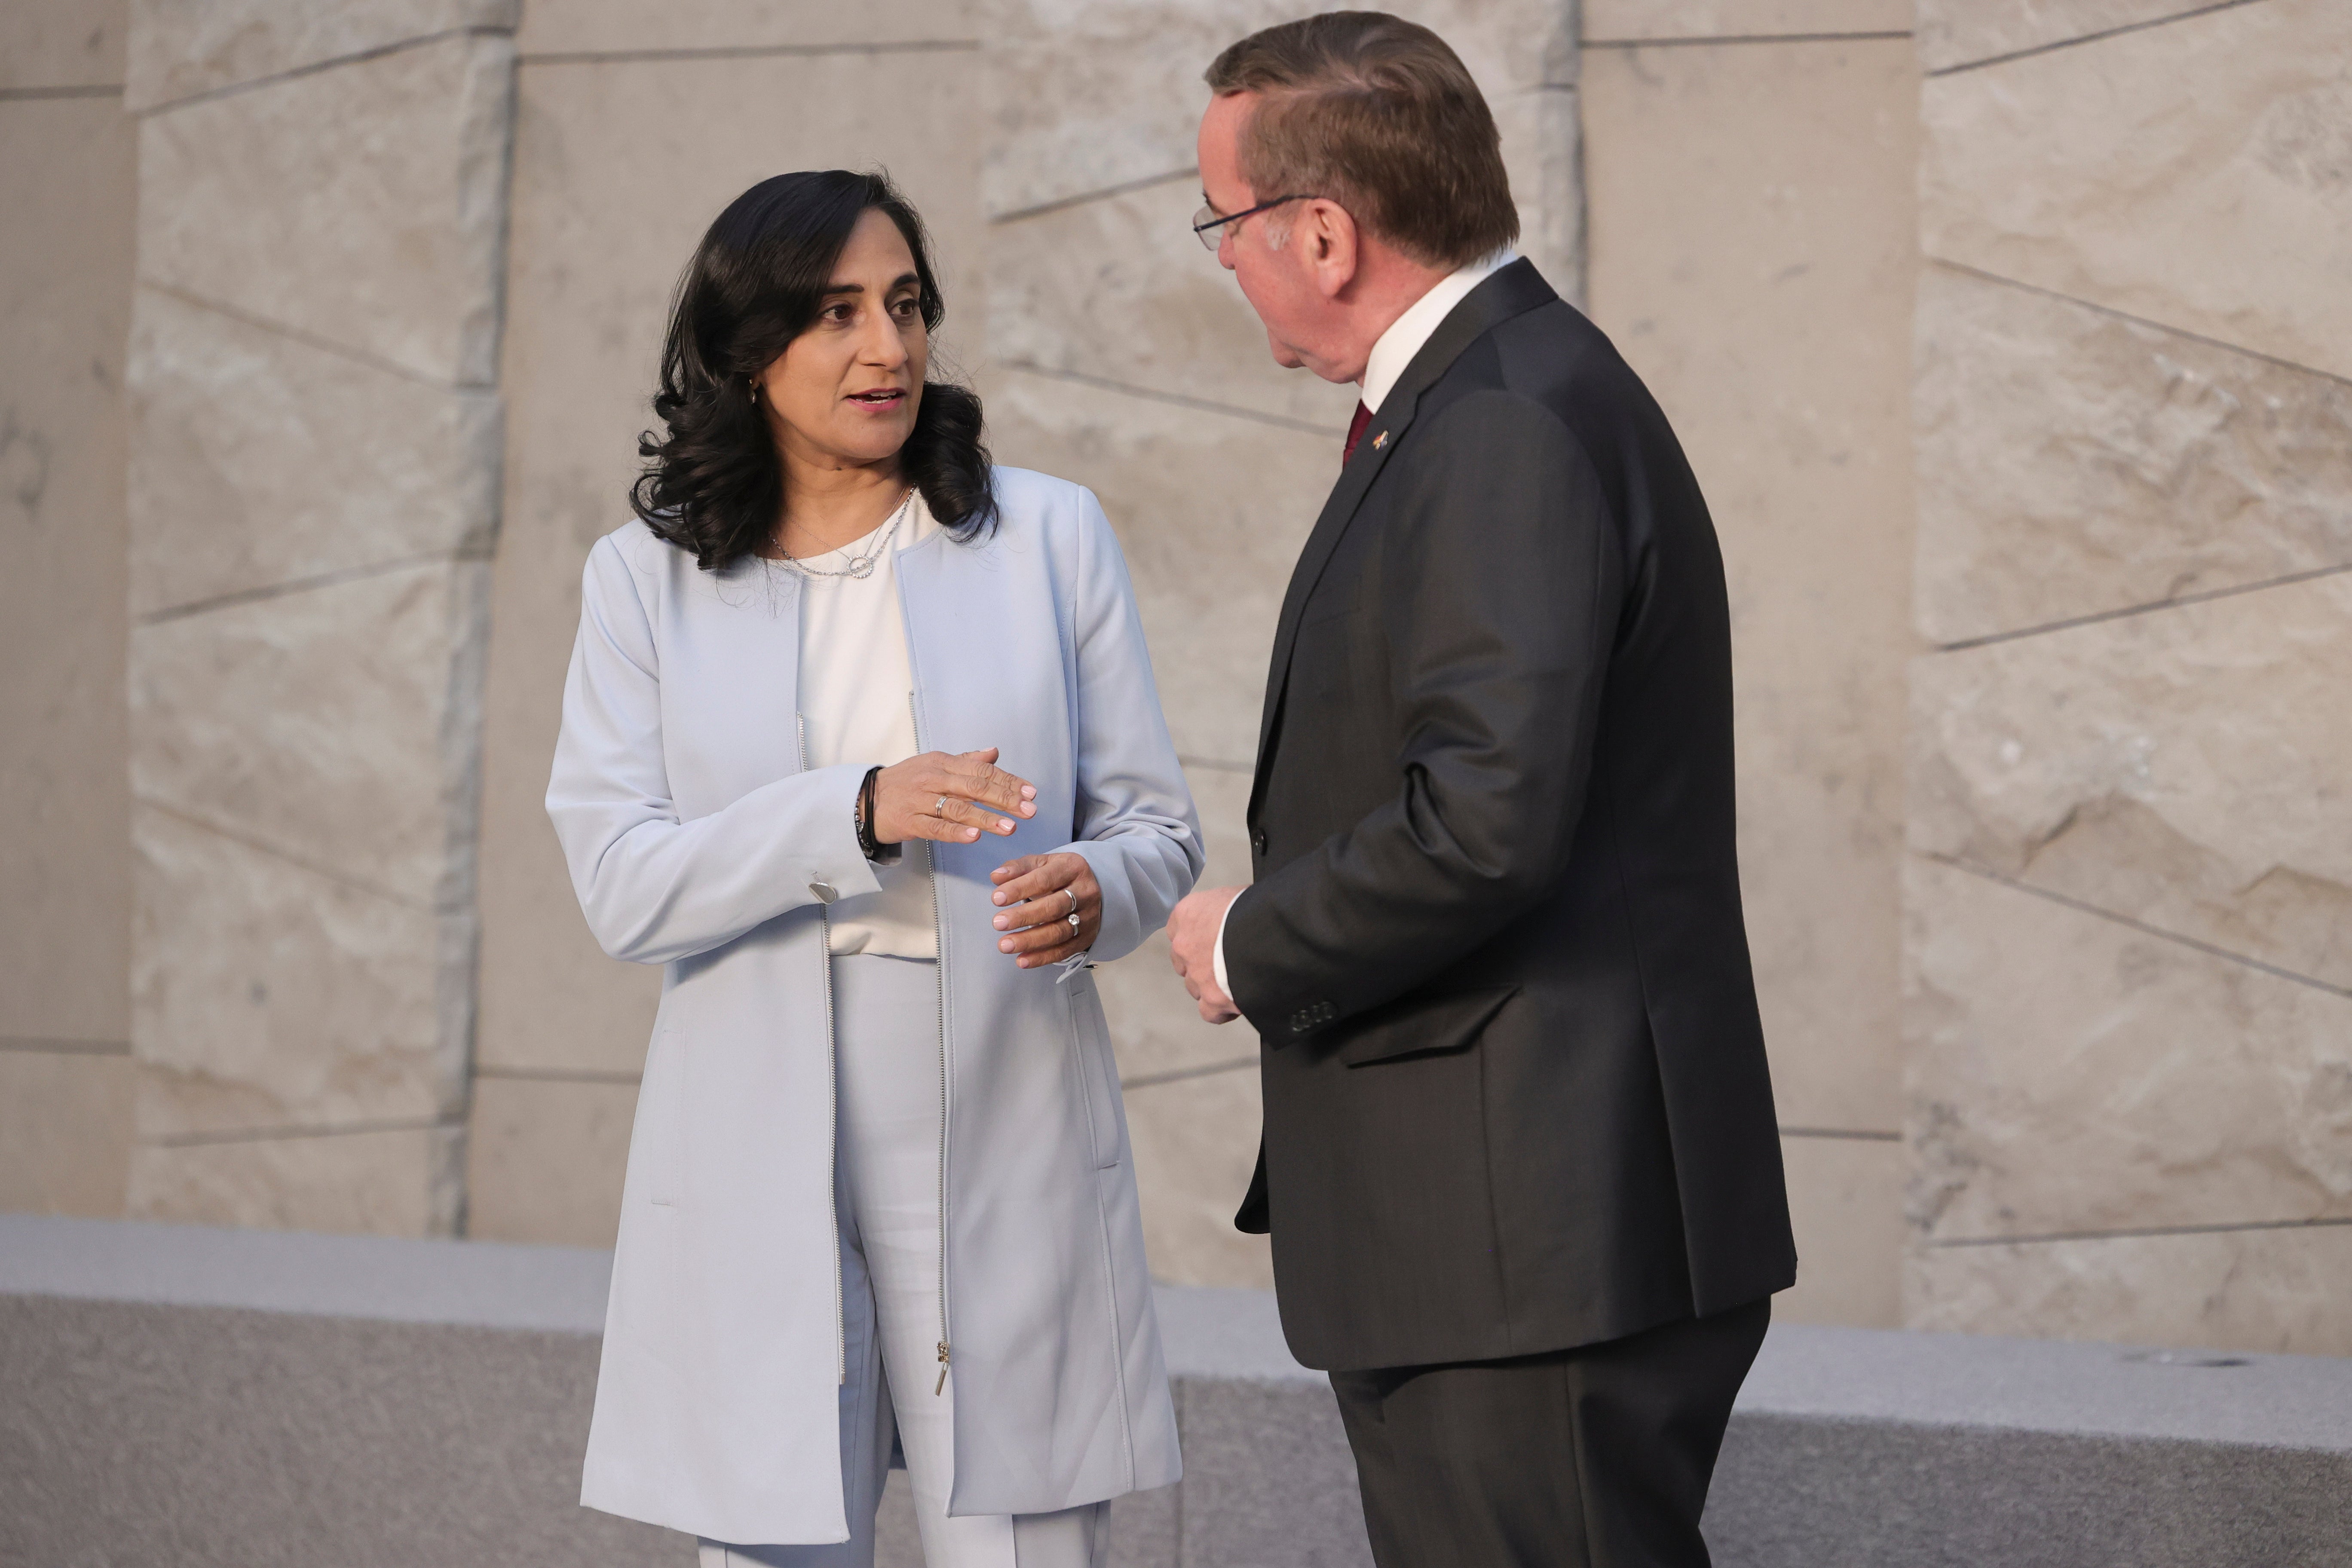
1063;491;1207;964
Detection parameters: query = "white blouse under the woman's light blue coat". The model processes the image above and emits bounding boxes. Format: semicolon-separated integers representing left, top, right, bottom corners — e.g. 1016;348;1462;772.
774;491;938;959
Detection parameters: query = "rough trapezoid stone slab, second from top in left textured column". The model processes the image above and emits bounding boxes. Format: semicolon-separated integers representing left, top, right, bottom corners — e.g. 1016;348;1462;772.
139;33;512;386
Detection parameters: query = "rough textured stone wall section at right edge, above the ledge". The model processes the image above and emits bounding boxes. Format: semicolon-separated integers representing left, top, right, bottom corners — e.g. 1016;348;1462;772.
1905;0;2352;1354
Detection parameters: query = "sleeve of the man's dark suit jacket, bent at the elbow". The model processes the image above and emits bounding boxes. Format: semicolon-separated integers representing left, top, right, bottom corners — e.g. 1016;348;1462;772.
1225;390;1625;1044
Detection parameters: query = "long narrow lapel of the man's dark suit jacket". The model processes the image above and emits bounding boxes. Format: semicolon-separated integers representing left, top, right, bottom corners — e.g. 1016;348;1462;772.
1249;259;1559;823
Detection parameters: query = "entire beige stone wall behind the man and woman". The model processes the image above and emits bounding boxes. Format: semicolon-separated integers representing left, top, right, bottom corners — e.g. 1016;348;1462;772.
0;0;2352;1352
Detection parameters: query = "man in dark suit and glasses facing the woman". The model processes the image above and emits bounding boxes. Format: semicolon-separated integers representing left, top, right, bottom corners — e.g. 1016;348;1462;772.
1169;12;1797;1568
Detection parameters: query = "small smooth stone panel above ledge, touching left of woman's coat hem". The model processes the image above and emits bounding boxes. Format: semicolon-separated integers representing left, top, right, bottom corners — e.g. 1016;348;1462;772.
466;1077;637;1246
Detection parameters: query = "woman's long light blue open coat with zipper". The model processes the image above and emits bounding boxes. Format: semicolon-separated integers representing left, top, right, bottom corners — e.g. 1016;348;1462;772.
548;468;1202;1542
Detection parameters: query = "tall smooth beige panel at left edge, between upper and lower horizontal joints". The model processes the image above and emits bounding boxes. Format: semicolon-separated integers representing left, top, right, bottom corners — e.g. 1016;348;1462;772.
0;92;136;1039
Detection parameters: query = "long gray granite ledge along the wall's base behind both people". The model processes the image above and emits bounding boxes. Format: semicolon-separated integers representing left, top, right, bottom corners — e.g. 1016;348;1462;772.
0;1216;2352;1568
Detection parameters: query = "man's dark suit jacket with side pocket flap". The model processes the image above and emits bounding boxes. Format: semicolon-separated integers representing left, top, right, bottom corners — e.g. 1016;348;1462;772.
1225;261;1797;1368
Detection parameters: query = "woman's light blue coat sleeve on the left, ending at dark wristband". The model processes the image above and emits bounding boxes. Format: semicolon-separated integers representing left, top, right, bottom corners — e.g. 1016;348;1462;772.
548;538;882;964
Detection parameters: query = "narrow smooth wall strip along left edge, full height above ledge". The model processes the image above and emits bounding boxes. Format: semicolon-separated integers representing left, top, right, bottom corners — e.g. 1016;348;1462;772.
0;0;136;1216
